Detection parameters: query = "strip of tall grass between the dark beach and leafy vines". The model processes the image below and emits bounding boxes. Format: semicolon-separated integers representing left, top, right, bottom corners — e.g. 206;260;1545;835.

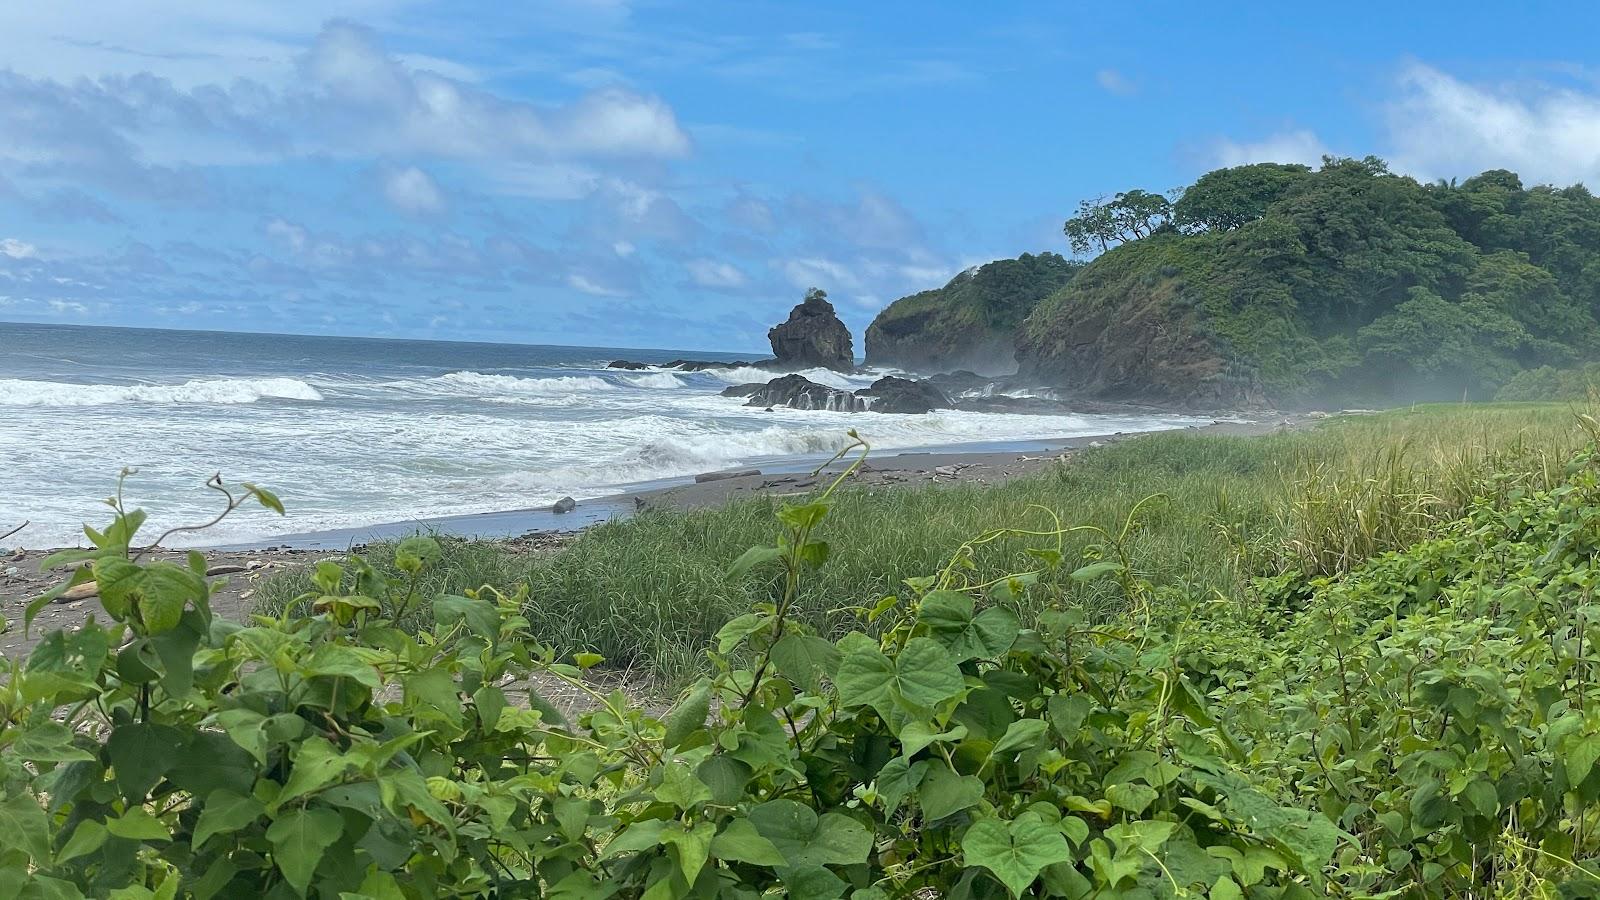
259;404;1587;681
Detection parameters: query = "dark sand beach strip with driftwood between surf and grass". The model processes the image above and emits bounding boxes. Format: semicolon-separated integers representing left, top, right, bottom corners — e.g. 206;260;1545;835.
0;418;1309;658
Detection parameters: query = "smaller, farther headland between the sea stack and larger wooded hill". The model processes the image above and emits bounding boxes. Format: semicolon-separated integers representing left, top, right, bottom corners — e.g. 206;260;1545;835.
866;253;1082;375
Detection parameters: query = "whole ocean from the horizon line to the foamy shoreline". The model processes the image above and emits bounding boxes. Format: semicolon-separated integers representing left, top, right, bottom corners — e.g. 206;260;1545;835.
0;323;1195;548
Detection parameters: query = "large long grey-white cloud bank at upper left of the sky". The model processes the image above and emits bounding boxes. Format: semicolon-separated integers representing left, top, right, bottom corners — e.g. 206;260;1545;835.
0;22;690;203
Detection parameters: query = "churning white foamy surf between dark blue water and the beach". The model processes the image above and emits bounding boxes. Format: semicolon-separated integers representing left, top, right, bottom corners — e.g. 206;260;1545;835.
0;349;1194;546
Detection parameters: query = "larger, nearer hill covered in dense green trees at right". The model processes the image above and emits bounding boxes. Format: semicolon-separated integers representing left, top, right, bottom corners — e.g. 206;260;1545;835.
1018;157;1600;405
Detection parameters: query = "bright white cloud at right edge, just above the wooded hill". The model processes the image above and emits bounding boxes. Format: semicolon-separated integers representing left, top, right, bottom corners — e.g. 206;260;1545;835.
1387;62;1600;184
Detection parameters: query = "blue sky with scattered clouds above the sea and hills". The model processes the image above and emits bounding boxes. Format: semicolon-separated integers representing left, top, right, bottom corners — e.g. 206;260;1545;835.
0;0;1600;352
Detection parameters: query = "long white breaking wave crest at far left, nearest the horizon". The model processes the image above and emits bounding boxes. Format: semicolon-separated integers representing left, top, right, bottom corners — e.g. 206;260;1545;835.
0;378;323;407
